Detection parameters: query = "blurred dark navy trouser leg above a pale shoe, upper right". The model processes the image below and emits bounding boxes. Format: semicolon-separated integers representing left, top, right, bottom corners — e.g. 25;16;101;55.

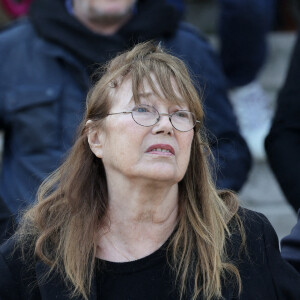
218;0;277;88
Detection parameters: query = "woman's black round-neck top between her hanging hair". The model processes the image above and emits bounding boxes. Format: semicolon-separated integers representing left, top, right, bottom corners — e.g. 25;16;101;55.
96;239;178;300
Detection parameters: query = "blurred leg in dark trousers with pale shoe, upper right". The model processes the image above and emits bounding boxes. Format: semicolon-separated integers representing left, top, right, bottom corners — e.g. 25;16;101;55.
167;0;277;160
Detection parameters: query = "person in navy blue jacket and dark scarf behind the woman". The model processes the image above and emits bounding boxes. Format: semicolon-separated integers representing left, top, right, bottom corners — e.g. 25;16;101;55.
0;0;251;244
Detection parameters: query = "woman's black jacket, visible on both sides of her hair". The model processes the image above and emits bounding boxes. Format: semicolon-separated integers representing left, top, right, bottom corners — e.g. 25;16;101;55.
0;210;300;300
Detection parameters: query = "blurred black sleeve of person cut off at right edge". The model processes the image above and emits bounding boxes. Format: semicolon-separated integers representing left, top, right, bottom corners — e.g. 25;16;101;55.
265;31;300;212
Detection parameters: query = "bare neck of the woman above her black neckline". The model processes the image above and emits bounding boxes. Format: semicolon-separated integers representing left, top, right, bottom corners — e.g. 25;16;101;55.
97;179;178;261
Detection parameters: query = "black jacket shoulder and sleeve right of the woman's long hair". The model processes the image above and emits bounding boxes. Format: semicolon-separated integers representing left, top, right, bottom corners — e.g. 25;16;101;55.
227;208;300;300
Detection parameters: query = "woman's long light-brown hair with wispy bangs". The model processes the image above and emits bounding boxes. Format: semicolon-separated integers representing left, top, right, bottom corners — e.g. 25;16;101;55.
16;42;243;300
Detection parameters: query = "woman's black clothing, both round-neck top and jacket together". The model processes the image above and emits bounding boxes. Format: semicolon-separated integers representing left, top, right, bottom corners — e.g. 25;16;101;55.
0;210;300;300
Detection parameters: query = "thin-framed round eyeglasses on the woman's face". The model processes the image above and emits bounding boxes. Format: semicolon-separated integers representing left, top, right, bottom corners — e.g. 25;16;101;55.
107;105;200;132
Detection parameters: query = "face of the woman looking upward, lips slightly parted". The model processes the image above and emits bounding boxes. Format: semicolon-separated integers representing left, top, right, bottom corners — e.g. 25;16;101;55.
89;80;194;184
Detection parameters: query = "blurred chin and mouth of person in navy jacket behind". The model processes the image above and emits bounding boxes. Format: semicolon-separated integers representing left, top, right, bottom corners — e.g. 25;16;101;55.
73;0;137;25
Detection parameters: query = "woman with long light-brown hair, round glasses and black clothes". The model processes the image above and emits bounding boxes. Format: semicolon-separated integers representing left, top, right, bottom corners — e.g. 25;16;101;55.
0;43;300;300
